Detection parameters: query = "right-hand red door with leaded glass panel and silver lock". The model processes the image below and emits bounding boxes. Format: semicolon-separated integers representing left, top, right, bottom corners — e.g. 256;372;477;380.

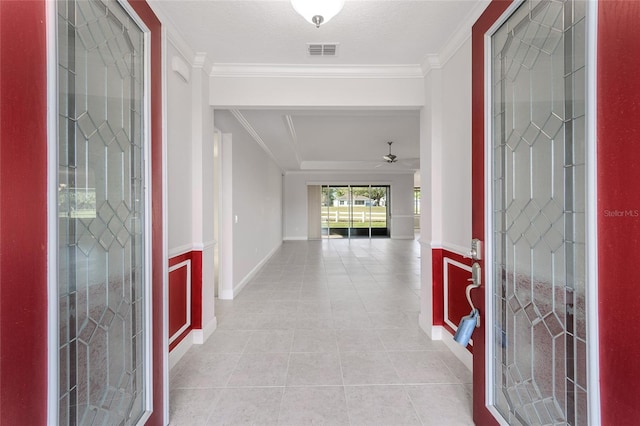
472;0;640;425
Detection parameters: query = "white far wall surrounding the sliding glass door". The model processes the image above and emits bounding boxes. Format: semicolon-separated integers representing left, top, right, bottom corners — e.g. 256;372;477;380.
284;171;414;240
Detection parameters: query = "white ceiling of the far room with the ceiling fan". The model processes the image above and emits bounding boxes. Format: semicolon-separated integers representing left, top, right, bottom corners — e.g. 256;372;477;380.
215;110;420;171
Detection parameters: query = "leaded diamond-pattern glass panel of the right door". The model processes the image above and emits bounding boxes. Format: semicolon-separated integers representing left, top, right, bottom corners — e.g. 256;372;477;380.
491;0;587;425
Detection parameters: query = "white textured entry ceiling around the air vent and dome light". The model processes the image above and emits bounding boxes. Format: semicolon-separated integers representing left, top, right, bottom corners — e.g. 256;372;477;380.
153;0;478;65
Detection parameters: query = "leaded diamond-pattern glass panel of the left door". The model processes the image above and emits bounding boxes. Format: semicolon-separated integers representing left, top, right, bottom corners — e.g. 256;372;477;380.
56;0;147;425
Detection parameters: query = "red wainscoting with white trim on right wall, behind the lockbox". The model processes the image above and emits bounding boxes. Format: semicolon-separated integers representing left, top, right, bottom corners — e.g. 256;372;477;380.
432;249;471;351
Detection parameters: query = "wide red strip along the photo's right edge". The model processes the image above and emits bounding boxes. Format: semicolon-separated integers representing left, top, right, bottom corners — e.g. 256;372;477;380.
597;0;640;426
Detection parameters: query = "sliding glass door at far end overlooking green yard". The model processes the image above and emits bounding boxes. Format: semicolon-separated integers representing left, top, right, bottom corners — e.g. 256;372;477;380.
320;185;390;238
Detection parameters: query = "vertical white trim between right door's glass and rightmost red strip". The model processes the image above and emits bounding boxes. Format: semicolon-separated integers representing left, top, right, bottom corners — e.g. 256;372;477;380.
585;2;601;425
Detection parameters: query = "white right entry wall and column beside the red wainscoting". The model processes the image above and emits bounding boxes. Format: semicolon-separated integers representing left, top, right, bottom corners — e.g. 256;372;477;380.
420;37;471;339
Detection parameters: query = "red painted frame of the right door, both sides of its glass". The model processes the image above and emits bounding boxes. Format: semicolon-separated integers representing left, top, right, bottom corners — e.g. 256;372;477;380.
472;0;640;425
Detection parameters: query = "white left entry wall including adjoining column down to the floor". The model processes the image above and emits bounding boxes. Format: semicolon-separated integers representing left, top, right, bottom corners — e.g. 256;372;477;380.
165;37;216;350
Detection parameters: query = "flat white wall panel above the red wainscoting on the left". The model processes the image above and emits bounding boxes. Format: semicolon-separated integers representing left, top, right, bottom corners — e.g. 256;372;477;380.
165;43;193;256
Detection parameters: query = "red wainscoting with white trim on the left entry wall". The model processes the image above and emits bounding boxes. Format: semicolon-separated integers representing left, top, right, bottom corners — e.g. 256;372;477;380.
169;250;202;351
